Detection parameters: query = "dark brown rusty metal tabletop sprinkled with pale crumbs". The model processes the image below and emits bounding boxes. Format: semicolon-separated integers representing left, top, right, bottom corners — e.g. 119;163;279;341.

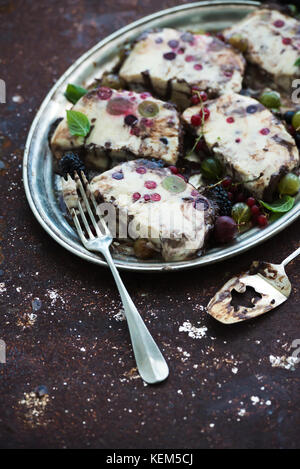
0;0;300;449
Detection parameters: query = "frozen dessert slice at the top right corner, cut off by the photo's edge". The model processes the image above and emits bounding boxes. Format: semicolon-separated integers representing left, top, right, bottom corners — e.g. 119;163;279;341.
224;8;300;92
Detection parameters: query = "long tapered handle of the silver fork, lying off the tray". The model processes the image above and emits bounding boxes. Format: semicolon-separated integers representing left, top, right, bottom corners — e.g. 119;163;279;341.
102;248;169;384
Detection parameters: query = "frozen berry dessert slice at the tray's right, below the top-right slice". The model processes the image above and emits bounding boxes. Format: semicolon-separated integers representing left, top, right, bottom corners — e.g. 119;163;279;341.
183;93;299;200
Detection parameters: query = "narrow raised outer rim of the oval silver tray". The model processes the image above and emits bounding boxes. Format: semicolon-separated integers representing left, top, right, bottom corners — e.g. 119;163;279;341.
23;0;300;272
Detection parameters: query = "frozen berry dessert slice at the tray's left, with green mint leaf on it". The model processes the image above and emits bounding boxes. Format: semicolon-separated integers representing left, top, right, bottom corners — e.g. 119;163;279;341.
51;87;182;169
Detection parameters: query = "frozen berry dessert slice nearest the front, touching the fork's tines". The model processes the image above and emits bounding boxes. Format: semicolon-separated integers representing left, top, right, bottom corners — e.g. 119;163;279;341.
73;160;215;261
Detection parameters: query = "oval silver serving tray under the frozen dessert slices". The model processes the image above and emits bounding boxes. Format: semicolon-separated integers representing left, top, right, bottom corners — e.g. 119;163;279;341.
23;1;300;271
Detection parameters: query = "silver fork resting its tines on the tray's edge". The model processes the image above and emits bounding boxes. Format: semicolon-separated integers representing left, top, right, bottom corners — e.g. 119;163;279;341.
71;173;169;384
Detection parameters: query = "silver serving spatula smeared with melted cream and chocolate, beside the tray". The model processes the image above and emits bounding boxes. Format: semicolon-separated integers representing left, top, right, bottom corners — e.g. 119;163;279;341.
207;247;300;324
